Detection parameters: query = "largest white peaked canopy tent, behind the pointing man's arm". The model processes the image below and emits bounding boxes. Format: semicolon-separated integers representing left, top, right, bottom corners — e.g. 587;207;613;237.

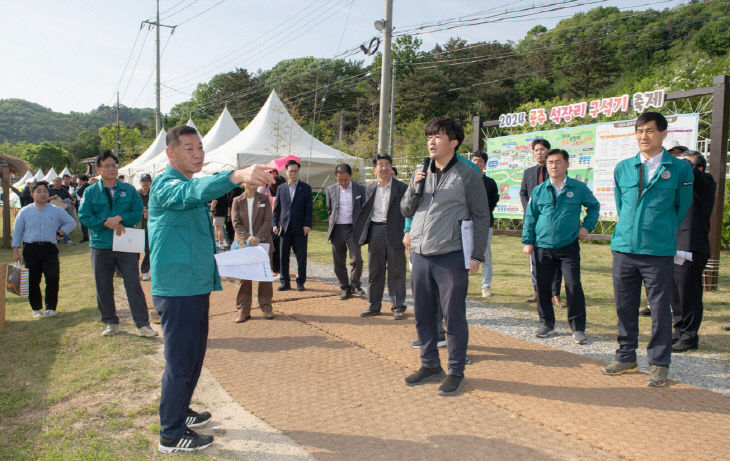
202;91;363;189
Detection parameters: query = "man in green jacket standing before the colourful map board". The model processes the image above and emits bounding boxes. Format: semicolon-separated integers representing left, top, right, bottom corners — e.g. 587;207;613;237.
522;149;601;344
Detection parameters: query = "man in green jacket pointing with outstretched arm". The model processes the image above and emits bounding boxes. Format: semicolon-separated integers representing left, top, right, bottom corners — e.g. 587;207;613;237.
147;125;274;453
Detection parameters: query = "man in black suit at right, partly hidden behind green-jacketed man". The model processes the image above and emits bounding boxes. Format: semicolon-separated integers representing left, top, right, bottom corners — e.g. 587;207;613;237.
672;151;717;352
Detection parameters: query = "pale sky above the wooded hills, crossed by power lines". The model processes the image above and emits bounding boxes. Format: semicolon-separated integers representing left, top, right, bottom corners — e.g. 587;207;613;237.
0;0;683;113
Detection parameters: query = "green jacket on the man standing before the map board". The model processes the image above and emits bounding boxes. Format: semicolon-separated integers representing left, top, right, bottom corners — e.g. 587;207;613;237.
522;178;601;249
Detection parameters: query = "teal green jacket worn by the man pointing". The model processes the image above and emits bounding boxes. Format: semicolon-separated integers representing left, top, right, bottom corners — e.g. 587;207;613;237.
147;165;236;296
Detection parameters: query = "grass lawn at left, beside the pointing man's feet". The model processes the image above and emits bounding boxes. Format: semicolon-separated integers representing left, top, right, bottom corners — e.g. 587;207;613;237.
0;229;204;460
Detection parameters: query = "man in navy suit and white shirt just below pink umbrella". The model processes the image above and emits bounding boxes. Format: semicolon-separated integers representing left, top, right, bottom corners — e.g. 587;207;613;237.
274;160;312;291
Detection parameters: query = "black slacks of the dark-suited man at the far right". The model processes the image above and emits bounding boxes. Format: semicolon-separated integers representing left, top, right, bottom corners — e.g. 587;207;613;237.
672;253;708;346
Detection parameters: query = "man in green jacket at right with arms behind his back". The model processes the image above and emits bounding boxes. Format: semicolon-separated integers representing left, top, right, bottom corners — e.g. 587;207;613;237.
601;112;694;387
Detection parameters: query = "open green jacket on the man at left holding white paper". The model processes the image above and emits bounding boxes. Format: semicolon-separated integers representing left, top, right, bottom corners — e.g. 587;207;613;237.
79;181;142;250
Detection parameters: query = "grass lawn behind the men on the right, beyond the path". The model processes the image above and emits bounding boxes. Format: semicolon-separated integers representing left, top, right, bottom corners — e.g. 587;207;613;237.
308;223;730;353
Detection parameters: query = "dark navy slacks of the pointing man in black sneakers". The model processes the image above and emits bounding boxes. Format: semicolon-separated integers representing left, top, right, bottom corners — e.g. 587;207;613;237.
152;293;210;440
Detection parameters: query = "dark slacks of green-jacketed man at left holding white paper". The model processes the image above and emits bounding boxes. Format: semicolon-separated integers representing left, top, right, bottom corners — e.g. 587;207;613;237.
91;248;150;328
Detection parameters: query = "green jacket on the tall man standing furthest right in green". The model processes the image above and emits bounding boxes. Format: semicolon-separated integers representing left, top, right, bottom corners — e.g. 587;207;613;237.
611;150;694;256
